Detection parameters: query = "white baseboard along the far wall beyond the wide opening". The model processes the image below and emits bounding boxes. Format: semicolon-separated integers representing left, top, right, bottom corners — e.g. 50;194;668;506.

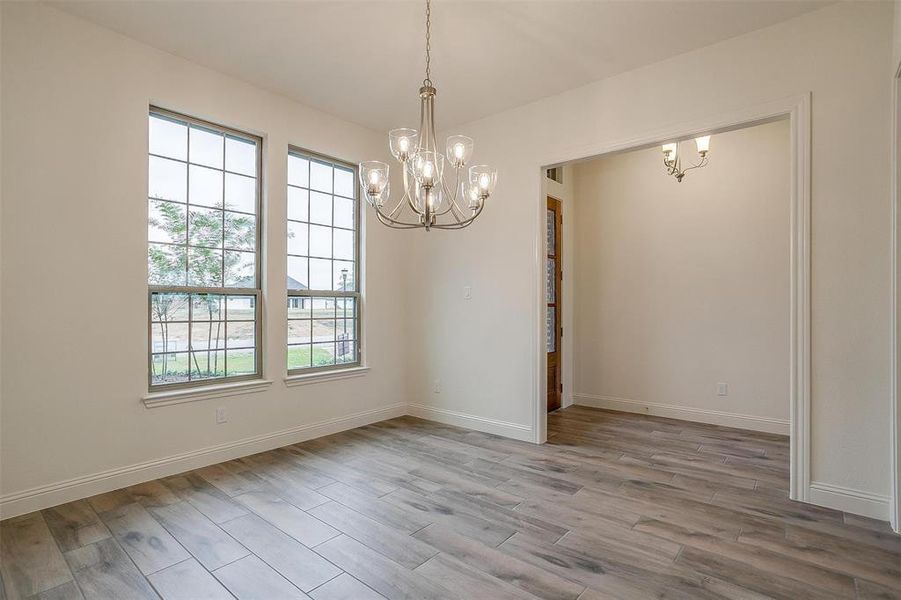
573;394;791;435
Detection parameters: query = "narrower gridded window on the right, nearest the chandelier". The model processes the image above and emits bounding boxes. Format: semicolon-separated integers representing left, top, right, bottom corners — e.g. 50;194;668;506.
288;148;360;374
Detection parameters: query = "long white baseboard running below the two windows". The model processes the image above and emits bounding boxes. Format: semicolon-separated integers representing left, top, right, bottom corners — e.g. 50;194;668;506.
0;403;407;519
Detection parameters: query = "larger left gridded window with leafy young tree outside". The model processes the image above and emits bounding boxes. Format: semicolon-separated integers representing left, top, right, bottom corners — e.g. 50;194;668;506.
147;108;262;390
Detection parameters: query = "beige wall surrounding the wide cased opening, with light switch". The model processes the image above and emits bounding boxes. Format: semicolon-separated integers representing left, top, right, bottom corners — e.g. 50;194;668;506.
412;2;893;509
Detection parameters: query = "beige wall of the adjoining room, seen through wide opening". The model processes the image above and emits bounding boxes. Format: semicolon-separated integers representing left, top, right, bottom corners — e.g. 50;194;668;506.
570;120;791;433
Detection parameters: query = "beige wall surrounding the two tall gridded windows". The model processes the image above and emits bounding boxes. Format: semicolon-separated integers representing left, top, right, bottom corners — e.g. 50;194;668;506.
0;2;407;507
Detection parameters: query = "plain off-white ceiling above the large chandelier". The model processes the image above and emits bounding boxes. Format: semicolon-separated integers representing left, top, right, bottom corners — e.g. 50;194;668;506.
51;0;825;130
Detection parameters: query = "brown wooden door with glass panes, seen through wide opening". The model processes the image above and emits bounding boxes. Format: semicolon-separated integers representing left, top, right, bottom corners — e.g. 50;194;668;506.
546;197;563;412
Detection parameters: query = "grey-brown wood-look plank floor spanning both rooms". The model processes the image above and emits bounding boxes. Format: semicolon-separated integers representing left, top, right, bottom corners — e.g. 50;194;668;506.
0;407;901;600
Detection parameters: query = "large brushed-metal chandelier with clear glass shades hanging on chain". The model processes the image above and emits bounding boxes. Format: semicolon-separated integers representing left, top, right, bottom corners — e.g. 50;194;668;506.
360;0;497;231
